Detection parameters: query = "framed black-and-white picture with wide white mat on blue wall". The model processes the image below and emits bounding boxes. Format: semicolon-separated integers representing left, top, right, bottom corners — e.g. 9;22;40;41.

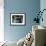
10;13;25;25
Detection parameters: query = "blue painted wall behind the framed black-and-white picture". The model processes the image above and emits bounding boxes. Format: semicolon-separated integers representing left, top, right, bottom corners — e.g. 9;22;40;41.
4;0;40;41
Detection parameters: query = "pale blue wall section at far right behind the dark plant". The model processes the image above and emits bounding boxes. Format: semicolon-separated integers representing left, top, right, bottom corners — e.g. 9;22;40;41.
40;0;46;27
